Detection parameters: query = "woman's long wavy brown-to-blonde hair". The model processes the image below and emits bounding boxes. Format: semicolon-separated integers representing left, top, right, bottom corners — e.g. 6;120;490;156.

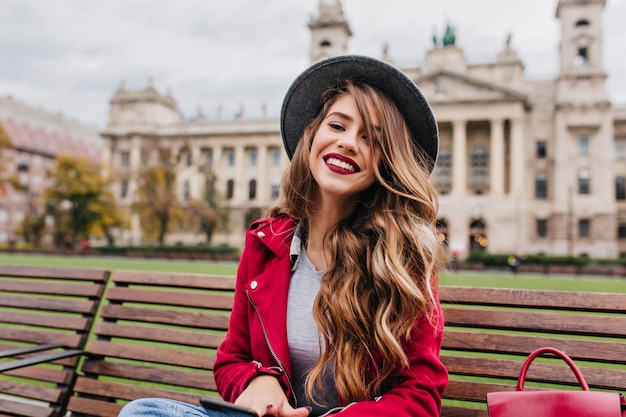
270;82;442;403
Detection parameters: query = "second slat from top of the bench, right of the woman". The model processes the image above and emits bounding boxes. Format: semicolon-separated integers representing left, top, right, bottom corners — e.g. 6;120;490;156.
444;307;626;338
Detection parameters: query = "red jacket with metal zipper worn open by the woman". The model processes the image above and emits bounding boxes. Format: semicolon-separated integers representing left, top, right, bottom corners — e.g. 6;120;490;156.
213;217;448;417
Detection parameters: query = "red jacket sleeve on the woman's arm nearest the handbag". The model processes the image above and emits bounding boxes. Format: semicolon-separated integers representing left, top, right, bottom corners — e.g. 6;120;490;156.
336;292;448;417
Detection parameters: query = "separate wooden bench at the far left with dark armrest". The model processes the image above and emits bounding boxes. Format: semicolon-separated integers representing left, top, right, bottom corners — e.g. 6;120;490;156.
0;265;109;417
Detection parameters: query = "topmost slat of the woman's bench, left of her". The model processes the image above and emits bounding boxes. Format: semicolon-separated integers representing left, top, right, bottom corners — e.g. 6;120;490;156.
113;271;235;291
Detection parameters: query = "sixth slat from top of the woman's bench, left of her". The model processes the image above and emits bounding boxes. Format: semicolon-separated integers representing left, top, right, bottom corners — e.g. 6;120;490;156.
81;359;217;391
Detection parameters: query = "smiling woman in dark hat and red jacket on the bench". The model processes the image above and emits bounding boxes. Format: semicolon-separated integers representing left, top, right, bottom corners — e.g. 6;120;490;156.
120;55;448;417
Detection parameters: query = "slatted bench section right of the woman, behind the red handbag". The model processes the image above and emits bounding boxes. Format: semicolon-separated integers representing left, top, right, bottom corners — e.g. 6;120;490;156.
440;287;626;417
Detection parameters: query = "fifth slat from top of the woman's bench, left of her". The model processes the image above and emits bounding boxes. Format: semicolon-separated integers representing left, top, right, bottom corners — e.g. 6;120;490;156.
88;340;215;369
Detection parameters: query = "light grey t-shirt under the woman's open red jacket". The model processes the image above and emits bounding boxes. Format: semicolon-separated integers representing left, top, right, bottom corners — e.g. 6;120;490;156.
287;249;339;416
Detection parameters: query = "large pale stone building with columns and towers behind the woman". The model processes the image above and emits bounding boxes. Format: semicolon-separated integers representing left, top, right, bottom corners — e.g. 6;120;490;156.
103;0;626;257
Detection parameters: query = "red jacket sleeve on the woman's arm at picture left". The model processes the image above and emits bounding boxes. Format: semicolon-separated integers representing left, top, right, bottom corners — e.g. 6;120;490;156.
213;242;279;402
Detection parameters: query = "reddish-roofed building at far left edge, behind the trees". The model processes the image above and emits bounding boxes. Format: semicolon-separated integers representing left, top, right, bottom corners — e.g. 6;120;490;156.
0;97;102;244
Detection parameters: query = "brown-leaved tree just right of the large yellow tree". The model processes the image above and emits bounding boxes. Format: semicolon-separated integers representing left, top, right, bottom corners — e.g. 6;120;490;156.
134;149;183;246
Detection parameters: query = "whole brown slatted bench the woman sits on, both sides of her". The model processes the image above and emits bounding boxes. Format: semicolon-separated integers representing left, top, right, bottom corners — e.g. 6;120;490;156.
61;271;626;417
